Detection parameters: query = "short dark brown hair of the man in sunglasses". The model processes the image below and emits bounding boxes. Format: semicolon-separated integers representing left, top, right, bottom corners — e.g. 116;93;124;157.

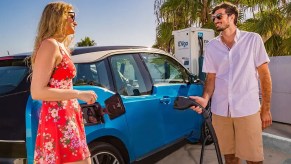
212;2;238;25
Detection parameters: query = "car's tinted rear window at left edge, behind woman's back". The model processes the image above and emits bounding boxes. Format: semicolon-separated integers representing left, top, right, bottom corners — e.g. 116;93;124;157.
0;59;29;95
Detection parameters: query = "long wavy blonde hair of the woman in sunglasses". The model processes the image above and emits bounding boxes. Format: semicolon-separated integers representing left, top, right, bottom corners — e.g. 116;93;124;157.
31;2;73;66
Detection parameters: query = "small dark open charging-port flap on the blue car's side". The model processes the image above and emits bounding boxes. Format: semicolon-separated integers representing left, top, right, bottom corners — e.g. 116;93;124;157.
105;93;125;119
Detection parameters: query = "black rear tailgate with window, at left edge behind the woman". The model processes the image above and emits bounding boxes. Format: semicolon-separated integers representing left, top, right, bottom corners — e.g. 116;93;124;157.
0;56;30;163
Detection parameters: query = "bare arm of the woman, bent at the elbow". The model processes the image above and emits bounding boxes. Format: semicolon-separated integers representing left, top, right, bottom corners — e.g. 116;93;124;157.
31;39;97;103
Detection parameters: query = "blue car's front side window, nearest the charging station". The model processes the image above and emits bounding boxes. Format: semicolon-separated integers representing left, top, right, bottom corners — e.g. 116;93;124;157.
141;53;189;84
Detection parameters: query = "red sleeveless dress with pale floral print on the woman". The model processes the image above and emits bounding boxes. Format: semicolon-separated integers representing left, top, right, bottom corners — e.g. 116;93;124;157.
34;48;90;164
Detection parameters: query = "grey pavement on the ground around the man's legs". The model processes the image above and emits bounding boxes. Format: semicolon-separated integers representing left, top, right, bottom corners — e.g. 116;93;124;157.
156;122;291;164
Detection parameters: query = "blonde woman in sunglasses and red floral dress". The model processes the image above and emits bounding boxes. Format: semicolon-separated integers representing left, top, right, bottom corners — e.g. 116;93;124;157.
31;2;97;164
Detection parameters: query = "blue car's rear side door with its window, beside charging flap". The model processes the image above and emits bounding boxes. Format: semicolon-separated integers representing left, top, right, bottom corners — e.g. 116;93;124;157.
109;54;165;159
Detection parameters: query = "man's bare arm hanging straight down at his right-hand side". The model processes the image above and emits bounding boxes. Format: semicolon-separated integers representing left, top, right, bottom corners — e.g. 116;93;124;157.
258;63;272;129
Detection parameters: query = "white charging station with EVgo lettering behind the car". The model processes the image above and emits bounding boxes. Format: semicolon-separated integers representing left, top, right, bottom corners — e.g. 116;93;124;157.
172;27;214;80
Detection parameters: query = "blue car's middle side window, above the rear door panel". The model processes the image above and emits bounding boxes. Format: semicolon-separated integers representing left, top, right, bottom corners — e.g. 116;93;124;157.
110;54;151;96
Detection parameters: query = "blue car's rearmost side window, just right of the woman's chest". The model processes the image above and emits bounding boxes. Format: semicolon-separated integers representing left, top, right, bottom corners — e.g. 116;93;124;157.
73;60;113;90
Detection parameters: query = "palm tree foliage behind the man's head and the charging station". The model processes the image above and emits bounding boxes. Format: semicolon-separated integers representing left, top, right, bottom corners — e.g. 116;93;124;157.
153;0;291;56
